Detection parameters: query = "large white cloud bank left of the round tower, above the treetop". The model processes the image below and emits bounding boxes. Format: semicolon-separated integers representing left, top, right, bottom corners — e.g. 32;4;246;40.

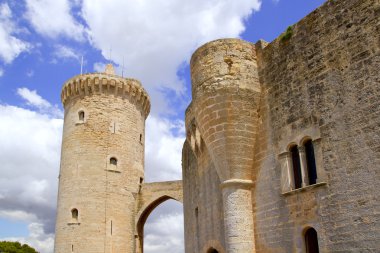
0;102;63;243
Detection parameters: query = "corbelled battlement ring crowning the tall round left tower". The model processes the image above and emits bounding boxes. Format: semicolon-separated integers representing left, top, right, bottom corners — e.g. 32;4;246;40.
61;73;150;117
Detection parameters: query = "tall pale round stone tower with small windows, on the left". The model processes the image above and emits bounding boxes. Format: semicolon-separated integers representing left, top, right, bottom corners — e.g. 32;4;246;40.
54;65;150;253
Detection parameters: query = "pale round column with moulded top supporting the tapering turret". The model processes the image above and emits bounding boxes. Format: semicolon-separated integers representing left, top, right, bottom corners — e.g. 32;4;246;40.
221;179;255;253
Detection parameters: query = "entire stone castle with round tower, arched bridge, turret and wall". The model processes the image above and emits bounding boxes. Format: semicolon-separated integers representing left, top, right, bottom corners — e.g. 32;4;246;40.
55;0;380;253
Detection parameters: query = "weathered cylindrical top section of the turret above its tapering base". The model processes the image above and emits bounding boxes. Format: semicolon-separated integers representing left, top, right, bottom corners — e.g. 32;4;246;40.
190;38;260;100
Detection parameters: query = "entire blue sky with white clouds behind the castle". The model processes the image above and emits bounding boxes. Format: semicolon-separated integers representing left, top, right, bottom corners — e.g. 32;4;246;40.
0;0;324;253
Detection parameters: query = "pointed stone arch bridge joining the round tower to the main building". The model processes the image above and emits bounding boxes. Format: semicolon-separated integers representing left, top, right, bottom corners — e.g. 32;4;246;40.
135;181;183;253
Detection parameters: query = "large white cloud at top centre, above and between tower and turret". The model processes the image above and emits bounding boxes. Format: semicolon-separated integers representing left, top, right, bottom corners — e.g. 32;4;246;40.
82;0;260;112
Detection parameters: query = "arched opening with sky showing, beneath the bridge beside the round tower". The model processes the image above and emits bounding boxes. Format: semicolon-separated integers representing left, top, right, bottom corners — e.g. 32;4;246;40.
137;196;184;253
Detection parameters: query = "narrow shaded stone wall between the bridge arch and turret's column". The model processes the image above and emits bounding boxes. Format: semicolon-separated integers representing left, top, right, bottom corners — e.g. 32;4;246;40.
182;142;226;253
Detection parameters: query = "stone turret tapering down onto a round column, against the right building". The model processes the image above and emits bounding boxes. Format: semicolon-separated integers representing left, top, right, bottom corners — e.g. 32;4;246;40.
191;39;260;253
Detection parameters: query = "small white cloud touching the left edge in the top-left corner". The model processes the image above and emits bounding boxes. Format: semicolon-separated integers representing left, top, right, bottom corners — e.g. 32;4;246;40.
0;3;31;64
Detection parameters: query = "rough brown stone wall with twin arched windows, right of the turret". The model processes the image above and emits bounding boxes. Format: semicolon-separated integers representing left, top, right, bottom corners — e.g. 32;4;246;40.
253;0;380;252
